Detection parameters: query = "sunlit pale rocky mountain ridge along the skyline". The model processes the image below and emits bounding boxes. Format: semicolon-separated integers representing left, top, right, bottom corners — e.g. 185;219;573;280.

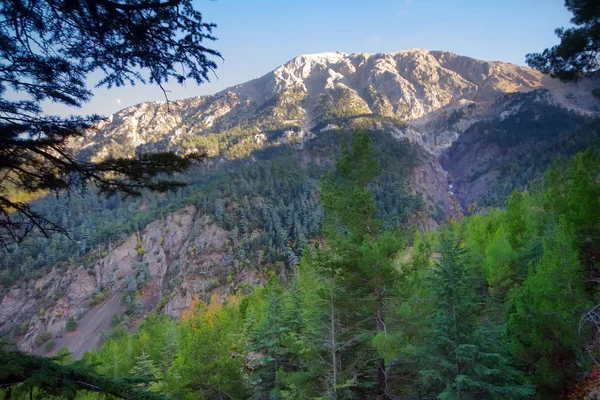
78;49;599;157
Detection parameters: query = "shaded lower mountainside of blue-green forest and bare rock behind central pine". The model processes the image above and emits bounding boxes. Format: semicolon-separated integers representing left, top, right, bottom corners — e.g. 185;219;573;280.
0;123;426;356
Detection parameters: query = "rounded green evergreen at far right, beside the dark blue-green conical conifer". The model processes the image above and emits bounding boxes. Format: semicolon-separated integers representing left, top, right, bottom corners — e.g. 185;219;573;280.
508;223;592;395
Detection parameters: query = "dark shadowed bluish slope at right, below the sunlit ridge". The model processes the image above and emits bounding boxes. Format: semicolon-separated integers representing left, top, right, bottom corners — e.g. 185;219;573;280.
441;91;600;210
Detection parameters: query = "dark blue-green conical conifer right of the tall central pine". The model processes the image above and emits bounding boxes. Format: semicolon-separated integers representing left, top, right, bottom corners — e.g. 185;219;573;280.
421;229;533;399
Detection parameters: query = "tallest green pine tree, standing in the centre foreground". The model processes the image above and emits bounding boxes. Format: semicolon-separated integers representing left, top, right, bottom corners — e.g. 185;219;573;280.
321;131;403;399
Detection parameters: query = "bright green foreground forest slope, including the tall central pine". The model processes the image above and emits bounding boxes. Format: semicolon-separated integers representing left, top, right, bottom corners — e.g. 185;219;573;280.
42;133;600;399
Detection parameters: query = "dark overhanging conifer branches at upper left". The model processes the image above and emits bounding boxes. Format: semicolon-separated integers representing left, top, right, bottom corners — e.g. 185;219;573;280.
0;0;220;246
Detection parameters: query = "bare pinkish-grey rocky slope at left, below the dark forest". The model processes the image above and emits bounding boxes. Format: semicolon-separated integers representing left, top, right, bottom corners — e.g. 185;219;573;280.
0;206;241;357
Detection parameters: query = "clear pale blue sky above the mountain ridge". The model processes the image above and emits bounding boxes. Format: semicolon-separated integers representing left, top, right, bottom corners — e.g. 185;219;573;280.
45;0;571;115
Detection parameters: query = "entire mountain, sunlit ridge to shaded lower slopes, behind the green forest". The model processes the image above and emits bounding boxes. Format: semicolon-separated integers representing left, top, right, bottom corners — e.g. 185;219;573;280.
0;50;600;357
